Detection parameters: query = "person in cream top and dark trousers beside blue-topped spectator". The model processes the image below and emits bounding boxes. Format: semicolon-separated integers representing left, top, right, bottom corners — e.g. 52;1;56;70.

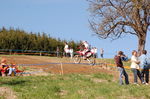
131;50;142;84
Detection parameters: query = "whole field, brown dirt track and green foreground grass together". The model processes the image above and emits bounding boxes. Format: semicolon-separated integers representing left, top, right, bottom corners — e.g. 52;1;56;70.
0;56;150;99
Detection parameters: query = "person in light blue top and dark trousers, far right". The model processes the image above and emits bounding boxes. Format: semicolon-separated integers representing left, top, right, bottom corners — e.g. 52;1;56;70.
139;50;149;85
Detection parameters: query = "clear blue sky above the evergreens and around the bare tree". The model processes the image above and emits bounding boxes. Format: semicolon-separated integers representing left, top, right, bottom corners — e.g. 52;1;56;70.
0;0;150;58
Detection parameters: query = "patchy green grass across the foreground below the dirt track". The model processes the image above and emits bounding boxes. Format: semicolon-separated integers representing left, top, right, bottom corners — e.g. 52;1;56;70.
0;73;150;99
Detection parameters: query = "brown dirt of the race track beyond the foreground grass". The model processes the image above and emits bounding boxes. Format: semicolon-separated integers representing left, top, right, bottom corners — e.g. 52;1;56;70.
1;55;134;80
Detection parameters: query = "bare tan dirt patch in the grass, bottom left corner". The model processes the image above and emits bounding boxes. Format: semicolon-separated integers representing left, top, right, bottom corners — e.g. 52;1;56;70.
0;87;17;99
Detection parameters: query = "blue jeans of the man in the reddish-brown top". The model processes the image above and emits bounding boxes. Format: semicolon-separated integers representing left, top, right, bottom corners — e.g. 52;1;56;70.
118;67;129;85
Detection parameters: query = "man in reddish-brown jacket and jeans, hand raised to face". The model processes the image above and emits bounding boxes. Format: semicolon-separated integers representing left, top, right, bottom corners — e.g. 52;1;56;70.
114;51;129;85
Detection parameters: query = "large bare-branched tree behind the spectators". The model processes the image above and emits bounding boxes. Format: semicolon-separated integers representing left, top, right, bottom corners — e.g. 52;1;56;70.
88;0;150;52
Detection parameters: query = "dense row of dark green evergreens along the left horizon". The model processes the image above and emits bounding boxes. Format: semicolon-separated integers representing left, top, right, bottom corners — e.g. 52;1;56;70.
0;27;79;52
